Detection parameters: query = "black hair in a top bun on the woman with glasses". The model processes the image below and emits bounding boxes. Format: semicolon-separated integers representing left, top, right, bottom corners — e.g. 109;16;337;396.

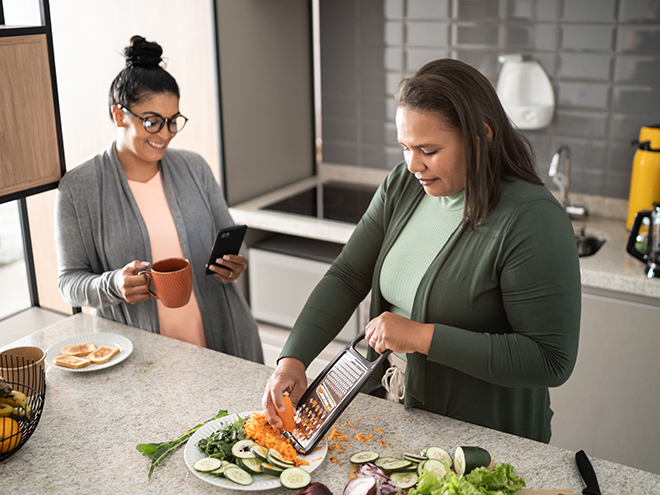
108;35;180;118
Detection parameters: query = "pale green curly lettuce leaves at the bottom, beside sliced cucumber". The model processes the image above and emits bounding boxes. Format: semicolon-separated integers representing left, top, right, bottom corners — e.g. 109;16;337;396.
409;464;525;495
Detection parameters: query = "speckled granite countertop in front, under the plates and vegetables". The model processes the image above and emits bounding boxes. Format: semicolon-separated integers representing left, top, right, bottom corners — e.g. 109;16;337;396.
2;314;660;495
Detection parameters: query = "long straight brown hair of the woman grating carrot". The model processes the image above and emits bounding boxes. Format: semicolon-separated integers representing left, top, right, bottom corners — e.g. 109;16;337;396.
394;59;543;229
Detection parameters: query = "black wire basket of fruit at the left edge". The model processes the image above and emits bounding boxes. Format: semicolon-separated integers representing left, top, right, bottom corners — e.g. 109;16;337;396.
0;353;46;462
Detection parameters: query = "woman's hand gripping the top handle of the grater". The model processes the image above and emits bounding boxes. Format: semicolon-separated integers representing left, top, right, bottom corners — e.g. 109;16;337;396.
365;311;434;356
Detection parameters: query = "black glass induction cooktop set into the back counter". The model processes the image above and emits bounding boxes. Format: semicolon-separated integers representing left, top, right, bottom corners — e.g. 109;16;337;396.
262;182;377;224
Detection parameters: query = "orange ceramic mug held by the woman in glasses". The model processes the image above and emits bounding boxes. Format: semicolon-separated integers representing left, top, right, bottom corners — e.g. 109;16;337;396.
138;258;192;308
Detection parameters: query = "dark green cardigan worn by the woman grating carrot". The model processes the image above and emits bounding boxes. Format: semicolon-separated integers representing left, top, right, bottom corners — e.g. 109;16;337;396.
281;164;581;442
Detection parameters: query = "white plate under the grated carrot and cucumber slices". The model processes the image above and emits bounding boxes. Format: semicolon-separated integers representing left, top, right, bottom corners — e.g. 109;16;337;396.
183;411;328;492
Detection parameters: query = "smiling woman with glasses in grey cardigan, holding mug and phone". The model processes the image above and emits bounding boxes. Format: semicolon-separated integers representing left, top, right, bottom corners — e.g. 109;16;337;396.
55;36;263;362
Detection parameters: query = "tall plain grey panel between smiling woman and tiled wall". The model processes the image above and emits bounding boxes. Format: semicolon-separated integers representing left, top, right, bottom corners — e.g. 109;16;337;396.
215;0;315;206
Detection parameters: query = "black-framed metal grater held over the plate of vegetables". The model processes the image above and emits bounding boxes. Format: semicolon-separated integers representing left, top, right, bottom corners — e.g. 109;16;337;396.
284;332;390;455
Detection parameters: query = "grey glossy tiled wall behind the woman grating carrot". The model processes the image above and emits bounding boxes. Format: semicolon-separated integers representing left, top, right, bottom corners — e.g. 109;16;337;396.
320;0;660;199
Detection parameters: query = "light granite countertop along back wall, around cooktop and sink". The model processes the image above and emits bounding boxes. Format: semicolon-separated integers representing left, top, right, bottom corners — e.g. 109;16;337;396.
230;165;660;304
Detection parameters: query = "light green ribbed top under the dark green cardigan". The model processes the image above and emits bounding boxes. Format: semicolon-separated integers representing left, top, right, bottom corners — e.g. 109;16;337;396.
380;190;465;318
